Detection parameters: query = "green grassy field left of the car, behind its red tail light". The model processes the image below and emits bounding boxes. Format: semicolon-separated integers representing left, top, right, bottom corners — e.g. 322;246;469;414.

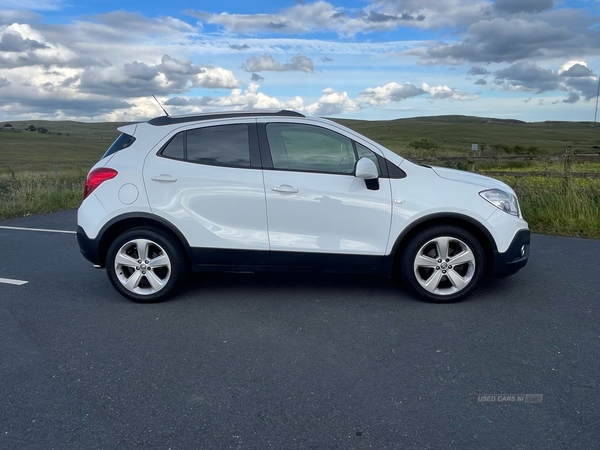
0;120;123;219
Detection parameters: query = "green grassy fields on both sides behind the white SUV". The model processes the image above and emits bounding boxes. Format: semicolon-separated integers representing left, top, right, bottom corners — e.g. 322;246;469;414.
0;116;600;238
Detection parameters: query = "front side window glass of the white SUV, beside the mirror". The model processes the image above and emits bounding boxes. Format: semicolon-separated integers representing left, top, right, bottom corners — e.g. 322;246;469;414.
267;123;356;175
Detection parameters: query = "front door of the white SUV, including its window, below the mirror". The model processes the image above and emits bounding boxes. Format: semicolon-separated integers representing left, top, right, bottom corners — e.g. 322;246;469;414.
261;123;391;267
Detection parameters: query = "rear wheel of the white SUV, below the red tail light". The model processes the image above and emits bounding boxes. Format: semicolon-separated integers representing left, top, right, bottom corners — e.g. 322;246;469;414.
106;228;186;303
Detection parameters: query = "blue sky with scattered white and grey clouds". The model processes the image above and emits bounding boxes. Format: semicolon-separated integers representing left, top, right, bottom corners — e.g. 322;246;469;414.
0;0;600;122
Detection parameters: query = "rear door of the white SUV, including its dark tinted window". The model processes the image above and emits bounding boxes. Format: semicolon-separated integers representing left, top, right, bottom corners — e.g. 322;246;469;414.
144;120;269;265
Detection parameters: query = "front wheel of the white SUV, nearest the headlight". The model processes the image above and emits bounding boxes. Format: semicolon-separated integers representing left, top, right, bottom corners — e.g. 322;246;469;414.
400;225;485;303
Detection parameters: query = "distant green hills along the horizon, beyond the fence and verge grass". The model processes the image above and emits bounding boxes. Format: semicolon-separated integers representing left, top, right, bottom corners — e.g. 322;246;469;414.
0;116;600;172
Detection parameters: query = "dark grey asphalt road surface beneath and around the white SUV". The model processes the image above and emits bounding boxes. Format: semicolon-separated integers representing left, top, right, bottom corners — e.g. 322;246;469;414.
0;211;600;450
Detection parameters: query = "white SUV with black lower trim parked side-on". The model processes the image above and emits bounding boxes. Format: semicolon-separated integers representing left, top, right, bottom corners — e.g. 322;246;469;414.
77;111;530;302
